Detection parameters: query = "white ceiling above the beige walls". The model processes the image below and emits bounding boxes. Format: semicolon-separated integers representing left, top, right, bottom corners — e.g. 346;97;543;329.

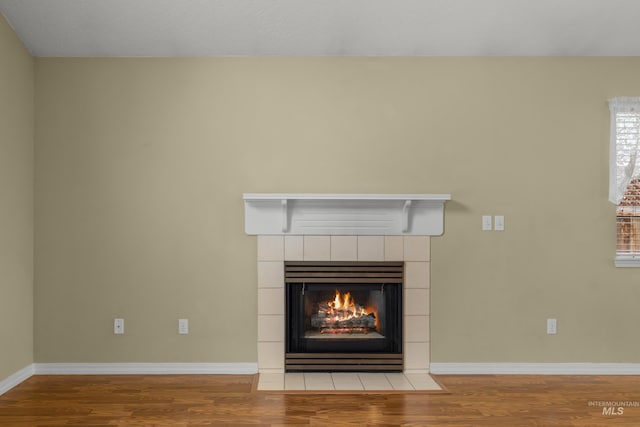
0;0;640;56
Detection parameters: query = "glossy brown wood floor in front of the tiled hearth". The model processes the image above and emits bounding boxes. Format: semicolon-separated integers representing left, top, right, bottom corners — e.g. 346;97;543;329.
0;375;640;427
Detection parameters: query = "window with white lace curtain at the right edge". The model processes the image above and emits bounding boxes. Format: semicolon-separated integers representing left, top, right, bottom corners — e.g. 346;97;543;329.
609;97;640;267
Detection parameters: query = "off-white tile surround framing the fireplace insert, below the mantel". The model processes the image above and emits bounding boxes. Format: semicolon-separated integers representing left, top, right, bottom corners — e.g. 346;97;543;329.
258;235;430;386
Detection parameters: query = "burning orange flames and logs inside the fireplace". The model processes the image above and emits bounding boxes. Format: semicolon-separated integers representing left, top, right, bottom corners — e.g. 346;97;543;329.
311;290;378;334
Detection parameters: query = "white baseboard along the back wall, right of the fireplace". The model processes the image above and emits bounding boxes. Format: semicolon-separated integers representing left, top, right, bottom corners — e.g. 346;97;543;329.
430;363;640;375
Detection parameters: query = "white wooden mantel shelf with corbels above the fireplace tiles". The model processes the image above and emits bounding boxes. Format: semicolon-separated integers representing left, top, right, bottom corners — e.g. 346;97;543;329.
243;193;451;236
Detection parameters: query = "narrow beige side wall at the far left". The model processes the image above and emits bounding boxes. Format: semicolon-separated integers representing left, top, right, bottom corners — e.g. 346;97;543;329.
0;15;34;381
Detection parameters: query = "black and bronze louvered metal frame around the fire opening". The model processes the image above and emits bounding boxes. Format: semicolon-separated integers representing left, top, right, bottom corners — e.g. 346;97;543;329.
285;261;404;372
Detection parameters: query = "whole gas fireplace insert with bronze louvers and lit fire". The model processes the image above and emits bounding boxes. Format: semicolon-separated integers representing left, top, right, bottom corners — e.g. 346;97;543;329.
285;261;404;372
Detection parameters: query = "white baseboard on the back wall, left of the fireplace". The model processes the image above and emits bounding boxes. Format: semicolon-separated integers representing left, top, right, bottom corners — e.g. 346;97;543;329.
35;363;258;375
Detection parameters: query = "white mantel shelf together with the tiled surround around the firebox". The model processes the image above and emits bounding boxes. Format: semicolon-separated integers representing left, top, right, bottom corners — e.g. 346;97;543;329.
243;193;451;374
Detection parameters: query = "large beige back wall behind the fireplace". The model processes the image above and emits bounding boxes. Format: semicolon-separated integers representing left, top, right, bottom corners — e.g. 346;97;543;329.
35;58;640;362
